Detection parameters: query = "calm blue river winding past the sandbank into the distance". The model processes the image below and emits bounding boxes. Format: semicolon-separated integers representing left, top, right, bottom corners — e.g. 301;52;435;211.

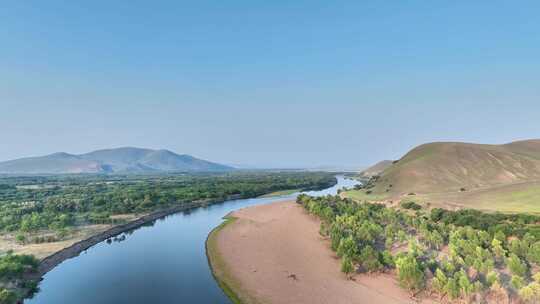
25;176;357;304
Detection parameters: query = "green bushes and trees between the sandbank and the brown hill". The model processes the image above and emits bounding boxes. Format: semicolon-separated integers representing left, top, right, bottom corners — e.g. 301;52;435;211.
298;195;540;303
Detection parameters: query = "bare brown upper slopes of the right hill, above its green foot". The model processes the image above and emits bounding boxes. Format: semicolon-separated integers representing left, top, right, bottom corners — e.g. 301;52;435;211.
373;140;540;194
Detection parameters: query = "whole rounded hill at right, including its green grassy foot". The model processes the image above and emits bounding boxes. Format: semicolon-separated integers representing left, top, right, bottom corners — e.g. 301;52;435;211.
348;140;540;212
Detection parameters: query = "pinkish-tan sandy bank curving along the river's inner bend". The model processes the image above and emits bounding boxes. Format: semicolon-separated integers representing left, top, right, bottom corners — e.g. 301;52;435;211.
208;202;434;304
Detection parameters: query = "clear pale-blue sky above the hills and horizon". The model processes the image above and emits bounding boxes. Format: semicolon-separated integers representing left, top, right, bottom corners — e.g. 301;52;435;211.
0;0;540;167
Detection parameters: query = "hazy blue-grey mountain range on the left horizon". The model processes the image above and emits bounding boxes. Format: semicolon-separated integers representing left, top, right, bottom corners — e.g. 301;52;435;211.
0;147;234;174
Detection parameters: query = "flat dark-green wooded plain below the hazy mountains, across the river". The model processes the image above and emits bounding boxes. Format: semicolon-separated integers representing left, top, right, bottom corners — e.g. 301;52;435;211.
0;172;336;235
